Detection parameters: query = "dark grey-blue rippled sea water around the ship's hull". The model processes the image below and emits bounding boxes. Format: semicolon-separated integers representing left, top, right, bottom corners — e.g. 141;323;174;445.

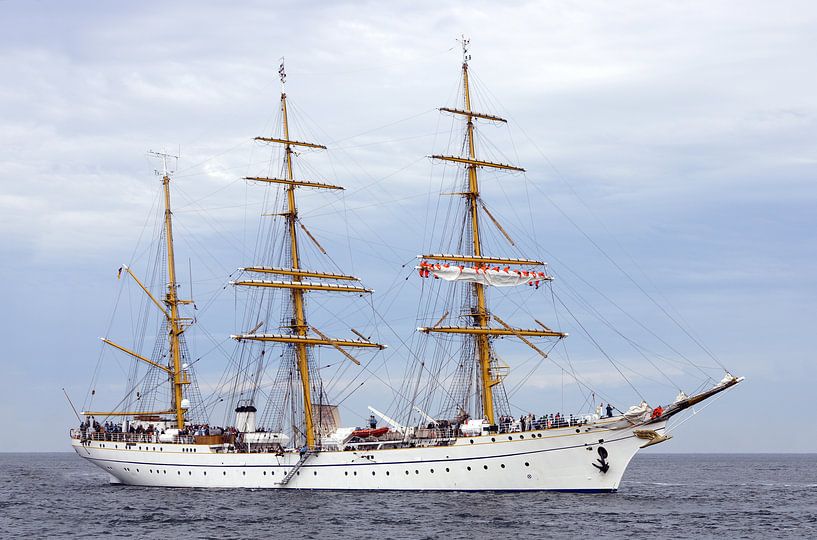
0;453;817;540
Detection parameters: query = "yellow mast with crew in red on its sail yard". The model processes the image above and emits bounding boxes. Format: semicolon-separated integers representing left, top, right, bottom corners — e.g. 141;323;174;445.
420;38;566;424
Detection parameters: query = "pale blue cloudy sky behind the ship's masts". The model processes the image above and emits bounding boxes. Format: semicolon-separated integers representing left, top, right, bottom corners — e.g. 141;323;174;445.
0;0;817;452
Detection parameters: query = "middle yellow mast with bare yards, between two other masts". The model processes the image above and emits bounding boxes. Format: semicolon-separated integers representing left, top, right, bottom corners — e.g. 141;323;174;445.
232;60;384;449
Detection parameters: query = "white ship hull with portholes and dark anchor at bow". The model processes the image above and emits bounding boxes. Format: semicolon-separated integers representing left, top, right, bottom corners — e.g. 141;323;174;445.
72;421;666;492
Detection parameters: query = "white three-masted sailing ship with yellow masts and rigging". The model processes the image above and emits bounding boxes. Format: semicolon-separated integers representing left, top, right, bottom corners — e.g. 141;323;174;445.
70;45;742;492
